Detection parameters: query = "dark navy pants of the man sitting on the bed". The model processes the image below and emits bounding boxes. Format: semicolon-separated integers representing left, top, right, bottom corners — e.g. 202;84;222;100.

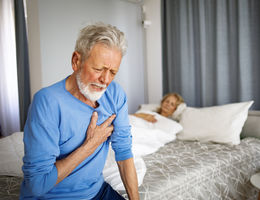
92;182;125;200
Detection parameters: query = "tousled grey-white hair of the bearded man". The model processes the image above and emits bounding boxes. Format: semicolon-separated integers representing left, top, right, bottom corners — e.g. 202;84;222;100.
75;22;127;61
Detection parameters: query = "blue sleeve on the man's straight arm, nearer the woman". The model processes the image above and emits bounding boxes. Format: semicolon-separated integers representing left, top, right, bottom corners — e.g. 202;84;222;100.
111;84;133;161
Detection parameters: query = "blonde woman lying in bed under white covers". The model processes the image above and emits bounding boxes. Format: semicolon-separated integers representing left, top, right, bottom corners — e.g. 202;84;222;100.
133;93;184;123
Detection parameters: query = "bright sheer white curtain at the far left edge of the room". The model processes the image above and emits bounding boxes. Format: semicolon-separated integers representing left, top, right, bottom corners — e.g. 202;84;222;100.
0;0;20;136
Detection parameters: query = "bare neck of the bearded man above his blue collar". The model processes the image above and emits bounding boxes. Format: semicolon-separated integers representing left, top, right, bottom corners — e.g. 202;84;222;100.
65;73;98;108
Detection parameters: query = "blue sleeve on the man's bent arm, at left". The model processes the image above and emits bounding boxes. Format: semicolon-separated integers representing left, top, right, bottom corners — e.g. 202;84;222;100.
23;91;60;196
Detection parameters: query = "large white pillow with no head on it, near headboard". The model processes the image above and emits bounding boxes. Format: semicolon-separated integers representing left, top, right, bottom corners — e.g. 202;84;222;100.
177;101;253;145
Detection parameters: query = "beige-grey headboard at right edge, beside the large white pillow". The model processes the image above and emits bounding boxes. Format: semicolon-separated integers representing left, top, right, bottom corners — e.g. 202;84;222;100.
241;110;260;139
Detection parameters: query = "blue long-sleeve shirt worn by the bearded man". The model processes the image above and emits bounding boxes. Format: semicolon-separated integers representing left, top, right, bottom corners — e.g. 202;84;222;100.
20;79;133;200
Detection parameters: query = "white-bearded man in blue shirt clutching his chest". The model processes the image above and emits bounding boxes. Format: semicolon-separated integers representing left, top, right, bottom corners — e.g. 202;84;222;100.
20;24;139;200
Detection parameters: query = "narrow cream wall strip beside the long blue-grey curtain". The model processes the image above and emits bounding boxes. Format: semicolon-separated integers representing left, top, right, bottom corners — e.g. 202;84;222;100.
143;0;163;103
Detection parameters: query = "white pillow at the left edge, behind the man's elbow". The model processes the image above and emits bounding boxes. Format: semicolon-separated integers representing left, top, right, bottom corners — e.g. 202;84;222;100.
0;132;24;177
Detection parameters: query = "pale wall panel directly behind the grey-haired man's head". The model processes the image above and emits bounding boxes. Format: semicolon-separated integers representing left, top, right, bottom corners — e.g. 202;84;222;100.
27;0;146;113
